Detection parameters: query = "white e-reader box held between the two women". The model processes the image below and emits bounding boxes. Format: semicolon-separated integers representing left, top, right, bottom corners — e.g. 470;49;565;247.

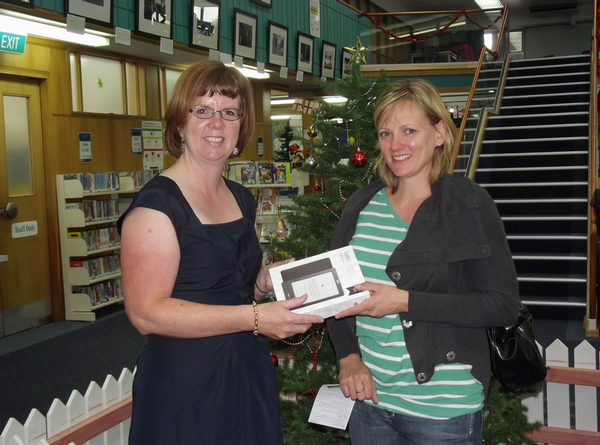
269;246;369;318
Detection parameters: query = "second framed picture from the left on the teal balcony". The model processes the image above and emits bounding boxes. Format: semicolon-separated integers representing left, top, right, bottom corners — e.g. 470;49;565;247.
135;0;173;39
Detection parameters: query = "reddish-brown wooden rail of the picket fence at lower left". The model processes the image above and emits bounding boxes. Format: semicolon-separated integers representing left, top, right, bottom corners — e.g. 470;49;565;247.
48;397;132;445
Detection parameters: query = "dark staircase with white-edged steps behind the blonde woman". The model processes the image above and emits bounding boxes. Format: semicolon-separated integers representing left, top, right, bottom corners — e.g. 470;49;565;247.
474;55;590;316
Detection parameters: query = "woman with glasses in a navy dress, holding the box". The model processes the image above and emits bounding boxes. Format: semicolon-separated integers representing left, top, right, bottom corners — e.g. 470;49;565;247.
118;62;323;445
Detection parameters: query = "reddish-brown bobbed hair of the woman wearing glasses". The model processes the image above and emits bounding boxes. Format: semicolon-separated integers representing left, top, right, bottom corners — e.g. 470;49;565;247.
165;61;254;157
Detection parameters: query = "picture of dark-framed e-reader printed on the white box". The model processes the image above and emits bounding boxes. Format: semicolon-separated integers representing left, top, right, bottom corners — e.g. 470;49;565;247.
281;268;344;306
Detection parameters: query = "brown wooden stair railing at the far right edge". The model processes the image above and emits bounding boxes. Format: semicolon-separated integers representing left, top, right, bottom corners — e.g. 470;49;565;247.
586;11;599;337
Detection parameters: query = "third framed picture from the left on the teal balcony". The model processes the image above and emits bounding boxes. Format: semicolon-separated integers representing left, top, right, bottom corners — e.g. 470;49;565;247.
190;0;221;51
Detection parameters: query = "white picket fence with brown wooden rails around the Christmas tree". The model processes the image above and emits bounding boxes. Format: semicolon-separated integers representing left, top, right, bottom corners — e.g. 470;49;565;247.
0;340;600;445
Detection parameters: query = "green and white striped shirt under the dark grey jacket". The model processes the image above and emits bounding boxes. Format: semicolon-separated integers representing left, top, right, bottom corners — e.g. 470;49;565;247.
350;189;484;419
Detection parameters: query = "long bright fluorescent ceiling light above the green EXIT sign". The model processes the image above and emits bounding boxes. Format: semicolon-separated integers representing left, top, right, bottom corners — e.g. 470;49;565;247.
0;11;110;46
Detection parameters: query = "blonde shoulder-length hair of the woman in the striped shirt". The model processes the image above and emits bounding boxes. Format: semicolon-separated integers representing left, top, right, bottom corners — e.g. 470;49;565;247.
374;79;457;192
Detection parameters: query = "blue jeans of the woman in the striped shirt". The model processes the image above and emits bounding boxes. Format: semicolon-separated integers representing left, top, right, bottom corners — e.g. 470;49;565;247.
349;402;483;445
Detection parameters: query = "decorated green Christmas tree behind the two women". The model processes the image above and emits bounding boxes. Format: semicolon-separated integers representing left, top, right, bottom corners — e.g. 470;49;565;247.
270;43;538;445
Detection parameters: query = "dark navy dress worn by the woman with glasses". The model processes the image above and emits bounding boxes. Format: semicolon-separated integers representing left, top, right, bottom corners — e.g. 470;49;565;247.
118;176;283;445
